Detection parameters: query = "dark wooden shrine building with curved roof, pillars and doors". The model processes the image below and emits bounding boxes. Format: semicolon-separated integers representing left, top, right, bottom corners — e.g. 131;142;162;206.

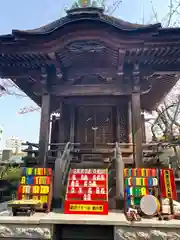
0;2;180;172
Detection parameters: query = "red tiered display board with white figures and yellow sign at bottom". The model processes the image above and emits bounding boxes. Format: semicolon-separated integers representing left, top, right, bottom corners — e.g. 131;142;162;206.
64;169;108;215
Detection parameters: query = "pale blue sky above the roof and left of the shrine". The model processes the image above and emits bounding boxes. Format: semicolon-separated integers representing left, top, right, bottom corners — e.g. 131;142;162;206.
0;0;168;145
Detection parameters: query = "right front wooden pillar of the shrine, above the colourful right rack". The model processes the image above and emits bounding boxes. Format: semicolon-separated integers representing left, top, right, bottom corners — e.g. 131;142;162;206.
132;64;143;167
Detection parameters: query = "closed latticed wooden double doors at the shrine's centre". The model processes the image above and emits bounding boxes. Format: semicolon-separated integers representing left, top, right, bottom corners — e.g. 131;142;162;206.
77;106;113;147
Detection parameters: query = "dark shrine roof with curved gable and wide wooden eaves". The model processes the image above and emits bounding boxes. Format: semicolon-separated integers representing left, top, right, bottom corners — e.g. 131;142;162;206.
0;7;180;110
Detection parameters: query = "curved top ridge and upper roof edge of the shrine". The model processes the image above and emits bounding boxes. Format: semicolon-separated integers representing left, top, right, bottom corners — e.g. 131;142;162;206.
7;0;161;37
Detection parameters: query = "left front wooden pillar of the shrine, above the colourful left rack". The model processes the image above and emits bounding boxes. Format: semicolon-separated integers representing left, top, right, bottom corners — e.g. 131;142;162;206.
39;93;51;166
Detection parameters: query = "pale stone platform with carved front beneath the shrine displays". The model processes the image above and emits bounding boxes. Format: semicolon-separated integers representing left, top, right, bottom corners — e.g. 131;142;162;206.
0;212;180;240
